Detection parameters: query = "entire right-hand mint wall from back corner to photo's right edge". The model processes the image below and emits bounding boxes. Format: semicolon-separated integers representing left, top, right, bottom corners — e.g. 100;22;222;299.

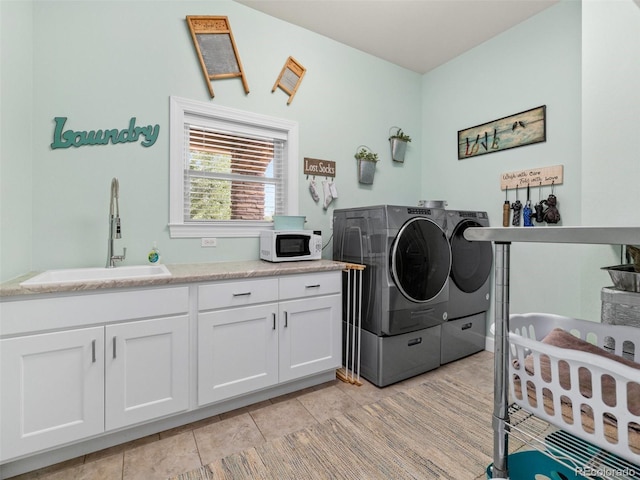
422;0;640;320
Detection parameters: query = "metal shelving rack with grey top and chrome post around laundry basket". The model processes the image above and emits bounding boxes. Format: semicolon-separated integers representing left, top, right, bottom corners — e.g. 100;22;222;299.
464;227;640;480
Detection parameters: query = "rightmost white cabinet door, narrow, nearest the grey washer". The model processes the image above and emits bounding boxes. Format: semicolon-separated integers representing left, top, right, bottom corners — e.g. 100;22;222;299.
279;295;342;382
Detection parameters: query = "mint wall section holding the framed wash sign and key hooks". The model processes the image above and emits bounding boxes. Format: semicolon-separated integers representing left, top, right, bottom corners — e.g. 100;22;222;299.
422;1;581;318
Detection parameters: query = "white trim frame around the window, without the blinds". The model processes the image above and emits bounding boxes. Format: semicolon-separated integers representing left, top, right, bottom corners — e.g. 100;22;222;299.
169;96;298;238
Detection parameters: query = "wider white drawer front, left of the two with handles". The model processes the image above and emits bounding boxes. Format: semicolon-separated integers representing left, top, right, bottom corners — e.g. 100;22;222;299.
198;278;278;310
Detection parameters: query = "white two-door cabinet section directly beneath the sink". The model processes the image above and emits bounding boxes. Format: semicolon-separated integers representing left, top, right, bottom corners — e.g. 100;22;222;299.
0;288;189;461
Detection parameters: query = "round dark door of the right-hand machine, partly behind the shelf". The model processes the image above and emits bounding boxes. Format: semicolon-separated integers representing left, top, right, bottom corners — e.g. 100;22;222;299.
451;220;493;293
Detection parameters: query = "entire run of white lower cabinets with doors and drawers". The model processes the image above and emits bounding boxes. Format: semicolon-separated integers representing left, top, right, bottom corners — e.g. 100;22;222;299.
0;271;342;464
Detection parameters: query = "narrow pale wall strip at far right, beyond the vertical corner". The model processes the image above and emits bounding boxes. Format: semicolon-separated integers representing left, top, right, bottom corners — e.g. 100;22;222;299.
581;0;640;322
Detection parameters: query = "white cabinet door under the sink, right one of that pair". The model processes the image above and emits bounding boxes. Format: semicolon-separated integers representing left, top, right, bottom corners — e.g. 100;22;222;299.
105;315;189;430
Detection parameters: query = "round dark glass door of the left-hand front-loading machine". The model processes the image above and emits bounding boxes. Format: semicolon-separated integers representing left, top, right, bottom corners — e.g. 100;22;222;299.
390;217;451;303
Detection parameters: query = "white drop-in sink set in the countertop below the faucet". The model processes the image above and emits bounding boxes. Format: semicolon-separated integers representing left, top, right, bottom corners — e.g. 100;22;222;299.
20;265;171;287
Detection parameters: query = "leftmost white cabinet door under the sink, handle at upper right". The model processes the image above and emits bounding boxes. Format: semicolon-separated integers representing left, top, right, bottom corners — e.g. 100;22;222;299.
0;327;104;460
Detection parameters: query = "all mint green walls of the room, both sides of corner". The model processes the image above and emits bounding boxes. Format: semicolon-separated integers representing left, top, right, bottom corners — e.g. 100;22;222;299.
0;0;640;330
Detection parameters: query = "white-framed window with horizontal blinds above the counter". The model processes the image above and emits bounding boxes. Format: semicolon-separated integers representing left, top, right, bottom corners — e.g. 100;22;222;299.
169;97;298;238
